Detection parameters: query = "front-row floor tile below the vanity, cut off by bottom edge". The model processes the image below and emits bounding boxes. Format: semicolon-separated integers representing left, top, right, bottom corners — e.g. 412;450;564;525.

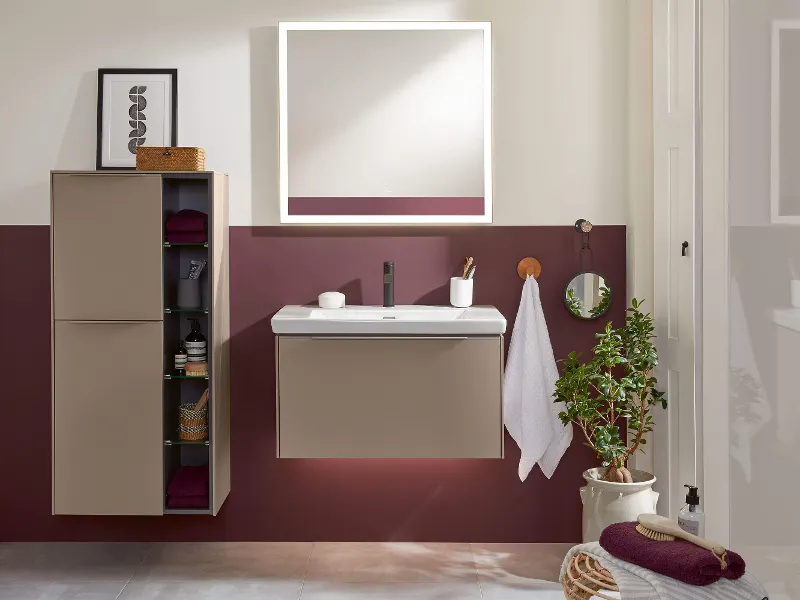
300;581;478;600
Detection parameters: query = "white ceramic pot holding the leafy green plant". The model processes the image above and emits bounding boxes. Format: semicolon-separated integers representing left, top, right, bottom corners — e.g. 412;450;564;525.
580;468;658;543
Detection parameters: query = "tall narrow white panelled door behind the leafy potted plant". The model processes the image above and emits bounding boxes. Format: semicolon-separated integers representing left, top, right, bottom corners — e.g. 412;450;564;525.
650;0;702;518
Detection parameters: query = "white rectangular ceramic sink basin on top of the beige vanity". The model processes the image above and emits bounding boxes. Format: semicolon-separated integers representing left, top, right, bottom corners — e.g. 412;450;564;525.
272;305;506;336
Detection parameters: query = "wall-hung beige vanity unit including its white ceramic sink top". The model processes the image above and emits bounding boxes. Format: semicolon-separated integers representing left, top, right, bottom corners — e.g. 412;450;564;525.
272;306;506;458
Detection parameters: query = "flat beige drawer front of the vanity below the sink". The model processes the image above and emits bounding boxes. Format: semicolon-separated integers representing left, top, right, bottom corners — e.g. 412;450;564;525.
278;336;503;458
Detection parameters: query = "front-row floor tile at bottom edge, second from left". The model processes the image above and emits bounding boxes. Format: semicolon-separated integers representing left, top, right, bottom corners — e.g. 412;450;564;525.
120;579;303;600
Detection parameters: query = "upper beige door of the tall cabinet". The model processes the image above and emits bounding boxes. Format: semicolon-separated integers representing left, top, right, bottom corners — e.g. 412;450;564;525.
52;174;163;321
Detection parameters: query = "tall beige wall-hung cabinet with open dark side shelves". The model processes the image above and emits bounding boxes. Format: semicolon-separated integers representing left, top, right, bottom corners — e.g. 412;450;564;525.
51;171;230;515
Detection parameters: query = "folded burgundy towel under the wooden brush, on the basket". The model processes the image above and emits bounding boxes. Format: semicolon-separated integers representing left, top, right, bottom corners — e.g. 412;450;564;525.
600;523;745;585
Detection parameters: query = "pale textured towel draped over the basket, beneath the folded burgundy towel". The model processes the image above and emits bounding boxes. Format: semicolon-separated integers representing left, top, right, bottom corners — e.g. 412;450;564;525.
560;534;767;600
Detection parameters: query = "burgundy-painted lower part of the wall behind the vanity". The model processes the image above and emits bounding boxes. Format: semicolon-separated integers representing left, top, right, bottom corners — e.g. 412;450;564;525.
0;226;626;542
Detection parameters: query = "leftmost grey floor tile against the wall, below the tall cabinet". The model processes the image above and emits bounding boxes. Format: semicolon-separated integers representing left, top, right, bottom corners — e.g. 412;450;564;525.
0;543;151;584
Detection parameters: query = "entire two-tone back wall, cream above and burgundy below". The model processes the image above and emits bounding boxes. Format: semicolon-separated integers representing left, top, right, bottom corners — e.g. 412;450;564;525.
0;0;652;542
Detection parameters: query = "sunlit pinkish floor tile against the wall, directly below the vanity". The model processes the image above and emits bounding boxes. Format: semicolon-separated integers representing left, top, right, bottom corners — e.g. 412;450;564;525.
306;542;477;583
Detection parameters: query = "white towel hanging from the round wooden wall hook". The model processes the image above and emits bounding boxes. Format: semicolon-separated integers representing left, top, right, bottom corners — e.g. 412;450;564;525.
503;276;572;481
